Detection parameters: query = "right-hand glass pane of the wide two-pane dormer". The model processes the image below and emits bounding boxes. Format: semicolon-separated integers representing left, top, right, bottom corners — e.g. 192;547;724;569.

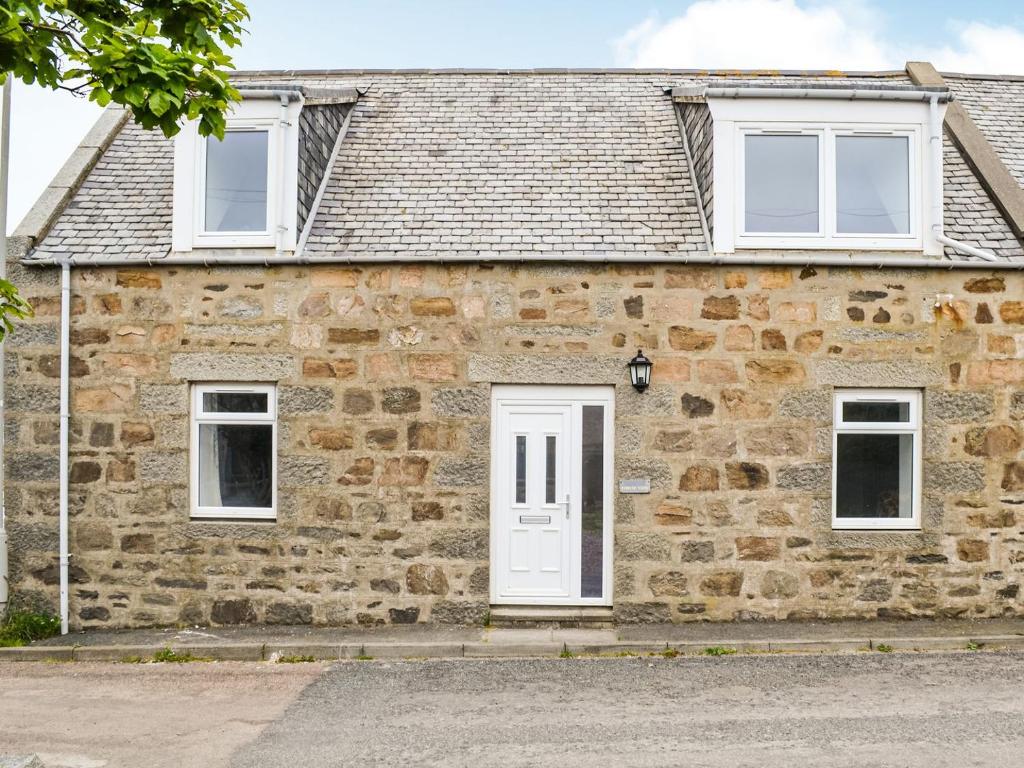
836;136;910;234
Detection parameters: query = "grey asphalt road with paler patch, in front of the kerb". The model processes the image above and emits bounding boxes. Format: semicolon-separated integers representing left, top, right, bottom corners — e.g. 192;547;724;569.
0;652;1024;768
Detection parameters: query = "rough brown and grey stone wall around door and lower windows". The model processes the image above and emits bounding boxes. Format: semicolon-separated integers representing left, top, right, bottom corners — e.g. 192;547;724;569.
6;256;1024;627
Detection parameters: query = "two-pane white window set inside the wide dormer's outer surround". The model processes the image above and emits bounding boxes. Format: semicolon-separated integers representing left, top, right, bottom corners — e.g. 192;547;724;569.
736;125;921;249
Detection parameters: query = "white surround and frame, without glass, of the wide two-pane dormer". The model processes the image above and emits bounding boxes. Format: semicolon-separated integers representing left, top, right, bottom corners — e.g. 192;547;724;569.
708;97;944;255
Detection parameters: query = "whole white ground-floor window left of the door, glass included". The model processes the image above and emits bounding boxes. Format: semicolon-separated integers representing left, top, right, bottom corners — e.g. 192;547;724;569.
190;384;278;520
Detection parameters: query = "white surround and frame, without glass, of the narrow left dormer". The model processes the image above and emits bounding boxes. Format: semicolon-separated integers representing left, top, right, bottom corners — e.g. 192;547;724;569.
173;94;302;252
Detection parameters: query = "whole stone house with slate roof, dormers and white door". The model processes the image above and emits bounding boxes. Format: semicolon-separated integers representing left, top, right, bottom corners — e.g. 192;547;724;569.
5;63;1024;628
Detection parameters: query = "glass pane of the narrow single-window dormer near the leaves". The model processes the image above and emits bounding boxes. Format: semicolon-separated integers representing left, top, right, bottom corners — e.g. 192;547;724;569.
206;131;269;232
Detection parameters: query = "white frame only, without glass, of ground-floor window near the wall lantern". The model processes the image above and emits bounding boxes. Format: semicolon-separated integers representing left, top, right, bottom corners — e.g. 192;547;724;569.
831;389;923;530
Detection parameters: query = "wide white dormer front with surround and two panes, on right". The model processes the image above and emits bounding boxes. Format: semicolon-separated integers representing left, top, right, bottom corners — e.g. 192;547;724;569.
709;98;942;255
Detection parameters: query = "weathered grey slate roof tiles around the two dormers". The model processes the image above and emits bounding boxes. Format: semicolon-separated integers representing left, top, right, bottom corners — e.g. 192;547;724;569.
22;71;1024;262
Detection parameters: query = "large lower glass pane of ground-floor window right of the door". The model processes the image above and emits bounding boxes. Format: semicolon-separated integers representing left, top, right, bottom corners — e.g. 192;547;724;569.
836;434;913;518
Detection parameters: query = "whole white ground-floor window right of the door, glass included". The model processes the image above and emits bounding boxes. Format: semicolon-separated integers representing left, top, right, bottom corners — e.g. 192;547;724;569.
833;389;922;530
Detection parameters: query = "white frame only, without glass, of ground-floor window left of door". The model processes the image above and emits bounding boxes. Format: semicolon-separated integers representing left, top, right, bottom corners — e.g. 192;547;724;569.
189;383;278;520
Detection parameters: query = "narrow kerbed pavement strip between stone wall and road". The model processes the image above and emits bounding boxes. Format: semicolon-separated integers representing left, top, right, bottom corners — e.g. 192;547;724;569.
8;618;1024;662
